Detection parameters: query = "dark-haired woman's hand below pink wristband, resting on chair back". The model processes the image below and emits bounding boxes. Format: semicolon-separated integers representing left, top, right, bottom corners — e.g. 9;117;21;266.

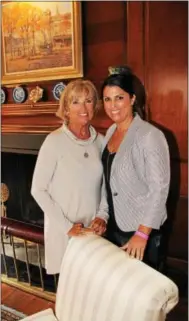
121;235;147;261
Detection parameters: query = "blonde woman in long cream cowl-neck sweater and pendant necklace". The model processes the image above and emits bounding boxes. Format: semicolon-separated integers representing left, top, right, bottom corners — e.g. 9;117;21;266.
31;80;108;274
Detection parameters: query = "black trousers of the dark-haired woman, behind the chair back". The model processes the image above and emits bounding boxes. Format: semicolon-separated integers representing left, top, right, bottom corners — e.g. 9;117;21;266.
105;228;164;271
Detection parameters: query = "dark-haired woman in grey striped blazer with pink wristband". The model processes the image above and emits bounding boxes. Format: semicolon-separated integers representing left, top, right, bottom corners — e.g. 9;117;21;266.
102;68;170;268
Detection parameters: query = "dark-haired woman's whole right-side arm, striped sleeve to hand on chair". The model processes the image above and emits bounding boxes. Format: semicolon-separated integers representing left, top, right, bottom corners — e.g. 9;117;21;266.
122;127;170;260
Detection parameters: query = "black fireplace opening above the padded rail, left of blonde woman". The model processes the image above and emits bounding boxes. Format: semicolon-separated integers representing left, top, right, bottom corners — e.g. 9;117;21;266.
1;152;44;226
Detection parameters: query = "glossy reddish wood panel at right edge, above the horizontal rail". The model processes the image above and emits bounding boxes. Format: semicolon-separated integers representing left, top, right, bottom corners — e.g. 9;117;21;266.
145;1;188;160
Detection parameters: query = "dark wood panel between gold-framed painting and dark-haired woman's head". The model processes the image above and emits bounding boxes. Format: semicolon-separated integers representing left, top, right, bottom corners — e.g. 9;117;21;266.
82;1;127;89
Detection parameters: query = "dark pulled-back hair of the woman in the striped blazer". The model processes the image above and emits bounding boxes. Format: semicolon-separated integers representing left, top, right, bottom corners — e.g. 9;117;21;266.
101;66;146;119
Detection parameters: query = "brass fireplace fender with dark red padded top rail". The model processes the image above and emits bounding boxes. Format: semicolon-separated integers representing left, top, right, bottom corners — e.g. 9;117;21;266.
1;217;58;301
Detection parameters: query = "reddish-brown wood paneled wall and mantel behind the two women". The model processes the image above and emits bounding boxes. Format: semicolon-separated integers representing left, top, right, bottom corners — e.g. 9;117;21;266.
2;1;188;259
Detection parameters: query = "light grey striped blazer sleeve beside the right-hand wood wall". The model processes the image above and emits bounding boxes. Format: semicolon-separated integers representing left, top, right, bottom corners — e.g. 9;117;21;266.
141;131;170;229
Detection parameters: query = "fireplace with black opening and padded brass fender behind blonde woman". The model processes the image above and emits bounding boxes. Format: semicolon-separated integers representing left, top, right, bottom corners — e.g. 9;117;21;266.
1;134;57;301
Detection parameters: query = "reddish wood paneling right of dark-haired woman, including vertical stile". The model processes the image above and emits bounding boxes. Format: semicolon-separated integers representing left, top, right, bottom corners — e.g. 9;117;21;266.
128;1;188;260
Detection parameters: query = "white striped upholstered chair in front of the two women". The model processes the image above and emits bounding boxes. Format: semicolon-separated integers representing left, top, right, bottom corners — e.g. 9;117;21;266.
20;235;178;321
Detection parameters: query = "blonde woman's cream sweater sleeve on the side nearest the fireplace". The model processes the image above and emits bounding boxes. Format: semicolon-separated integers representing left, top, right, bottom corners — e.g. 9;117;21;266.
31;134;73;233
